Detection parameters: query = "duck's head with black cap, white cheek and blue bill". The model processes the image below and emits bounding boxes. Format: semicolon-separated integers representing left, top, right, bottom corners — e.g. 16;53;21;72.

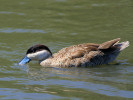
19;44;52;65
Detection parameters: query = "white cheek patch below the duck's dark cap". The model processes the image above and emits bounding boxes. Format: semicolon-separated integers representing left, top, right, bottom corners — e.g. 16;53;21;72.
27;50;50;60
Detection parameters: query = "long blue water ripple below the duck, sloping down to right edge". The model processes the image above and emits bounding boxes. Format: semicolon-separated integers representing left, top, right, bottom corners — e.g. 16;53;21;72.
18;79;133;98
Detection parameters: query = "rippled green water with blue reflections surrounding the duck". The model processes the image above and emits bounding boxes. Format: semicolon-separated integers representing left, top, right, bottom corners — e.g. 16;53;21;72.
0;0;133;100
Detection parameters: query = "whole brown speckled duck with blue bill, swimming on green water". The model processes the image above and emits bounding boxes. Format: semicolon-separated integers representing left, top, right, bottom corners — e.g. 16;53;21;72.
19;38;129;67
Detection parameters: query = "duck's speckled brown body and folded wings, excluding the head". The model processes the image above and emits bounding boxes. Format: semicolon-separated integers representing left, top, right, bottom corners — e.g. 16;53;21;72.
40;38;129;67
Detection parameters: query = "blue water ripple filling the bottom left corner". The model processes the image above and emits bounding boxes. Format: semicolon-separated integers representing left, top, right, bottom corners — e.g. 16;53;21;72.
0;88;66;100
